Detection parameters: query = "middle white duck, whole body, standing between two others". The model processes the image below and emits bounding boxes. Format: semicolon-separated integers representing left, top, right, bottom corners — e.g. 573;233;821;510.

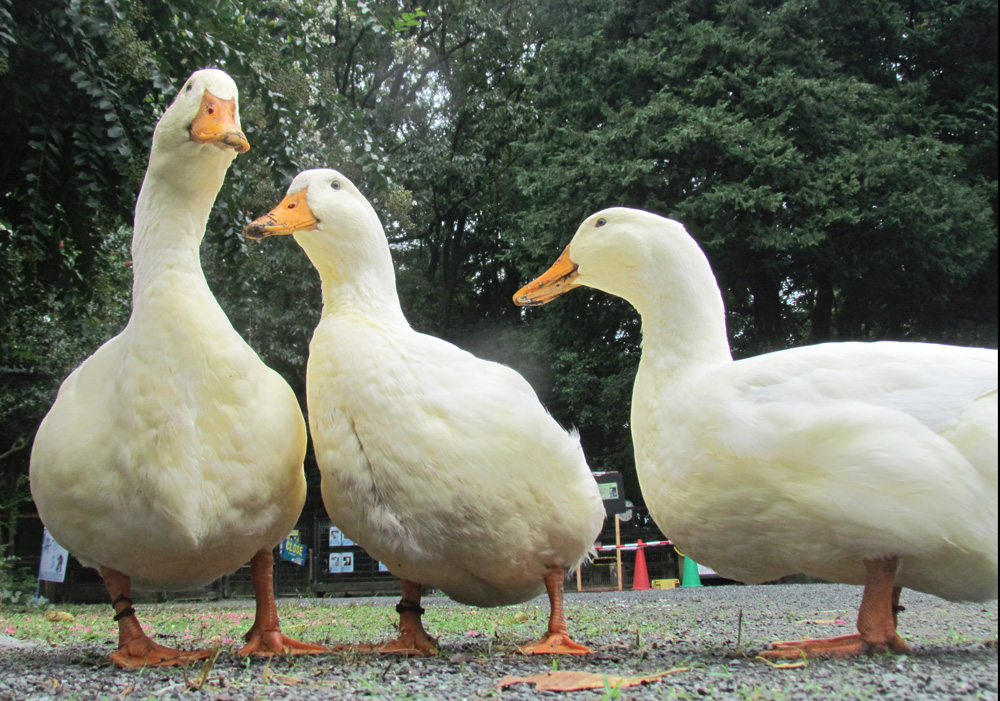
244;170;604;654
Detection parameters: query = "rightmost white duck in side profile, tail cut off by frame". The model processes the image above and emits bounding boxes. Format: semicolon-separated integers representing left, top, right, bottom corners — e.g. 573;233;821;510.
514;208;997;657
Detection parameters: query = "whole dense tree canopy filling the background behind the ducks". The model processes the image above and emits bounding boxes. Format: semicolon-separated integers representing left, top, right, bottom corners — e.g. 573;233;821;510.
0;0;997;532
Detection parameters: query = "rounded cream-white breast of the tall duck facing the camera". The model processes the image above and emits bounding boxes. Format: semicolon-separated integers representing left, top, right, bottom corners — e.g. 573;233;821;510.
32;304;305;583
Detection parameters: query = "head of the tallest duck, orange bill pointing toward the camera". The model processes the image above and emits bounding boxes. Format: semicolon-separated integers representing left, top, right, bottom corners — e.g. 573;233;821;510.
150;68;250;185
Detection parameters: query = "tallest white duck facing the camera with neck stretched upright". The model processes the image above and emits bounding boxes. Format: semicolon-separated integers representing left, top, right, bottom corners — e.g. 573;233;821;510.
31;70;325;667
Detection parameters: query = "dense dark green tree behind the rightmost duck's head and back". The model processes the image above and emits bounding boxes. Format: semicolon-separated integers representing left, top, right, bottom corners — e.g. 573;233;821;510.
519;2;996;354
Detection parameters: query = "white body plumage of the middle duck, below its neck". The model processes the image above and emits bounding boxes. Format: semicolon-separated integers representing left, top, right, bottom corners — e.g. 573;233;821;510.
308;314;604;606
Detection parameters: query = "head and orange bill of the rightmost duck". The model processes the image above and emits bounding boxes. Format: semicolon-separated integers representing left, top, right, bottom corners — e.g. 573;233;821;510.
514;207;714;313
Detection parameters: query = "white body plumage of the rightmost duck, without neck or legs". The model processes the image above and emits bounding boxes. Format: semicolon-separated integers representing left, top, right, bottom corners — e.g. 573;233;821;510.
634;343;997;601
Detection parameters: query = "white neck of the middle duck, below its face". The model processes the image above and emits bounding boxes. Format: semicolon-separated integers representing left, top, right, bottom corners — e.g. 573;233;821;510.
295;217;406;324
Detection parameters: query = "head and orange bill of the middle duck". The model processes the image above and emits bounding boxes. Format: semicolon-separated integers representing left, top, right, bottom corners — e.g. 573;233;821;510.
243;168;395;294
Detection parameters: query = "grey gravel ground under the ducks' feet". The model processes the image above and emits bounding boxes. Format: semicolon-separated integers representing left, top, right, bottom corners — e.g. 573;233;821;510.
0;584;997;701
